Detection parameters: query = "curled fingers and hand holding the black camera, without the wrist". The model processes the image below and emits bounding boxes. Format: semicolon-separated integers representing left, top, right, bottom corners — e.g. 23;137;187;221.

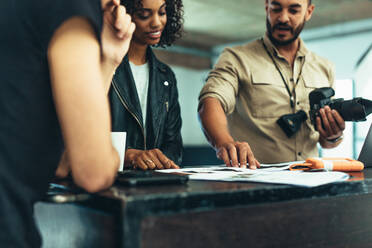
316;106;345;140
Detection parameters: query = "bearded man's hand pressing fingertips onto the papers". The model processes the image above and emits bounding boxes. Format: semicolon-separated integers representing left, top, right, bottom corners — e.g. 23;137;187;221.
217;141;260;169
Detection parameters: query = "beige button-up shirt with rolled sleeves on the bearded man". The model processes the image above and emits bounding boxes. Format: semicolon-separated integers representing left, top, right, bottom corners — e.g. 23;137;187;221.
199;36;334;163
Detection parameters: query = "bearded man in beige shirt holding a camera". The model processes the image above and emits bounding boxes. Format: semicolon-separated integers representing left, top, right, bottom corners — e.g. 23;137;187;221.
198;0;345;169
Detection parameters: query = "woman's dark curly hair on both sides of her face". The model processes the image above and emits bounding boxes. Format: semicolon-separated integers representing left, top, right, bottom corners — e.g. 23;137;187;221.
120;0;183;47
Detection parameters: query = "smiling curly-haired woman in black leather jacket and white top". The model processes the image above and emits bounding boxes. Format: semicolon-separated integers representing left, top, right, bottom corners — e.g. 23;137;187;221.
109;0;183;170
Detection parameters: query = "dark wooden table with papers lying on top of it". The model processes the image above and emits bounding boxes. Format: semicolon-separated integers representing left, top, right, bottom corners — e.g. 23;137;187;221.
35;169;372;248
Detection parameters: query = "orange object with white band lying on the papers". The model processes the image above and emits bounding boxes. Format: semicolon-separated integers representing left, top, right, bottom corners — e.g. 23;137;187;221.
289;158;364;171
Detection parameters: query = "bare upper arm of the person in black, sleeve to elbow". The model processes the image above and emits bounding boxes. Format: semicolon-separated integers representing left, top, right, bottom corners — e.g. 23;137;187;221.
48;17;132;192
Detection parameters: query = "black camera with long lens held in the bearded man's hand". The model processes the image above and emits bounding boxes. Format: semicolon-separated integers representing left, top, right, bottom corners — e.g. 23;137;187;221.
309;87;372;127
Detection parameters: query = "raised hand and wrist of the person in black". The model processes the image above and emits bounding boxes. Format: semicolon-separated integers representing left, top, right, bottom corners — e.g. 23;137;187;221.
101;0;135;68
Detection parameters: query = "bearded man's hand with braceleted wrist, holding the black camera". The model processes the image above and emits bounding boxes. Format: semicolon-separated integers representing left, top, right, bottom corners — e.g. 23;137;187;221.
316;106;345;148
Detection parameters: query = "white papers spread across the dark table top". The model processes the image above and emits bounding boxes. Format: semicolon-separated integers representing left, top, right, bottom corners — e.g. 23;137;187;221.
158;161;349;187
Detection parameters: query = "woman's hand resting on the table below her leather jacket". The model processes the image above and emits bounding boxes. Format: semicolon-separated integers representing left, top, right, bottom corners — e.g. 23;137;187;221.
125;149;180;170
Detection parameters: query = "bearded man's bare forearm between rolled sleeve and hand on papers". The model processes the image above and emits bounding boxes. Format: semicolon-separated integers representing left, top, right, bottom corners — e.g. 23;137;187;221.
199;97;234;148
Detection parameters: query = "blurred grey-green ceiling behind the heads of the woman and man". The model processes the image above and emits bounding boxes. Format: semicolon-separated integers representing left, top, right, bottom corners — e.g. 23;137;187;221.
177;0;372;50
